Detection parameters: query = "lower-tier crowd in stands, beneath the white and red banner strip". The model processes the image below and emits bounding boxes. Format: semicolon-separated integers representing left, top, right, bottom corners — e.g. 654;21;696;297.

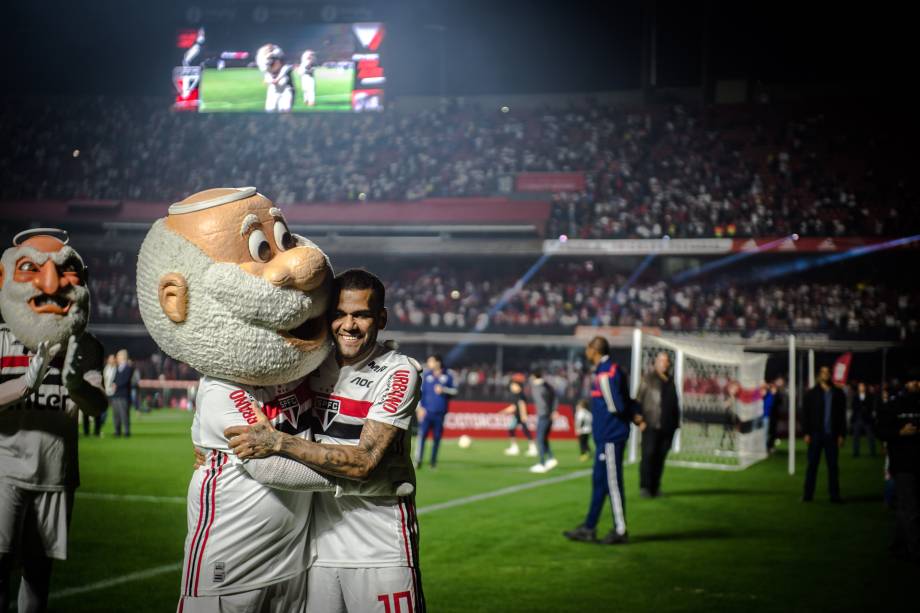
82;252;920;338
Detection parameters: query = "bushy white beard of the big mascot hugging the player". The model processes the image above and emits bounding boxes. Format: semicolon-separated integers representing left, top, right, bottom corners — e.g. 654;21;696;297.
137;220;331;385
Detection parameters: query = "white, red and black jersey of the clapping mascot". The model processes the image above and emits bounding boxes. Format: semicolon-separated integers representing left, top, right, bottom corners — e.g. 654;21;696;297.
0;324;102;491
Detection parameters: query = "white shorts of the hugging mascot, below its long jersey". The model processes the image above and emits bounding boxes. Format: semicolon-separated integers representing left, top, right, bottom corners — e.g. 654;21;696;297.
176;571;307;613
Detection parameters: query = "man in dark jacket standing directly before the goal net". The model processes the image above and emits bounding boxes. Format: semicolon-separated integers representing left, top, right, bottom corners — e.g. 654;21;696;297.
636;351;680;498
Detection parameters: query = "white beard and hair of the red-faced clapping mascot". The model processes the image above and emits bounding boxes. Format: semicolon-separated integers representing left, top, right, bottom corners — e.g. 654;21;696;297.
0;246;89;351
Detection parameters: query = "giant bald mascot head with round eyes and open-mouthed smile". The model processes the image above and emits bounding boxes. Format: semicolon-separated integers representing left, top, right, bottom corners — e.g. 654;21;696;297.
137;187;332;385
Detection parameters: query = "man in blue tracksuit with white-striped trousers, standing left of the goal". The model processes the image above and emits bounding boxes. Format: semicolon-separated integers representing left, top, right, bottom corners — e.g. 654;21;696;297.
563;336;645;545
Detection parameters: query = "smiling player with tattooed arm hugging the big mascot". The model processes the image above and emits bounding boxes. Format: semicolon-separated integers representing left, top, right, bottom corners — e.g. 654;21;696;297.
226;270;425;613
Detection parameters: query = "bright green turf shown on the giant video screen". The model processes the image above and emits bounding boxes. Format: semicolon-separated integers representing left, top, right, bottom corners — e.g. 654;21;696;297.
200;67;354;112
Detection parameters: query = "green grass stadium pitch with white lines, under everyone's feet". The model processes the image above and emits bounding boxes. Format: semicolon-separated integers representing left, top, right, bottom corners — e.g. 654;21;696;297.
23;410;920;613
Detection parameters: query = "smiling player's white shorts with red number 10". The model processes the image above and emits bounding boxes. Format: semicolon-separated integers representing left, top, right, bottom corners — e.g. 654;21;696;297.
307;566;425;613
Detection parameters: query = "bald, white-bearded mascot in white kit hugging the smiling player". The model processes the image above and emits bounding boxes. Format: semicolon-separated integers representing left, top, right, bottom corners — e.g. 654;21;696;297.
137;187;406;612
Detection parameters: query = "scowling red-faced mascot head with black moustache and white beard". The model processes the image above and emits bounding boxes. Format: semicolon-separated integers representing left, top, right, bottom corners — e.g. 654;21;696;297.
0;228;89;351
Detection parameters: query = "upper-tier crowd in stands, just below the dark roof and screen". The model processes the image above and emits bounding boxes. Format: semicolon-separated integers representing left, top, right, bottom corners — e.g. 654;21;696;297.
0;98;920;238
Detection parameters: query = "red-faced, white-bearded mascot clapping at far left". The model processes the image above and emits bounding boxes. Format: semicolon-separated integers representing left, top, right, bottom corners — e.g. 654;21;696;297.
0;228;108;611
